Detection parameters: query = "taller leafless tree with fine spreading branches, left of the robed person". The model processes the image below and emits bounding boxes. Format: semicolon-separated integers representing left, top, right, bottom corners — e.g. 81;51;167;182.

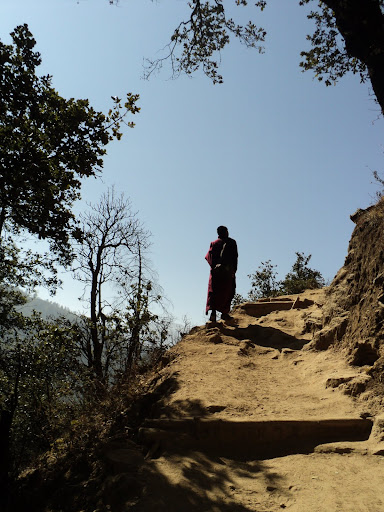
74;188;149;382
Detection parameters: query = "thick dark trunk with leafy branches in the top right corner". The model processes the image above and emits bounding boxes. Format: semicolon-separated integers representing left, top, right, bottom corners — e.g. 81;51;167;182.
300;0;384;112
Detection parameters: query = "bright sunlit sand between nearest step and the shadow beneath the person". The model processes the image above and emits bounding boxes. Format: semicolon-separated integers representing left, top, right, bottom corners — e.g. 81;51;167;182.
162;329;364;419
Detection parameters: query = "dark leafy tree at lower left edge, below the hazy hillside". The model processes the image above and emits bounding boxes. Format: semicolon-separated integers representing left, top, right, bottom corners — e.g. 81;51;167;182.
0;310;80;510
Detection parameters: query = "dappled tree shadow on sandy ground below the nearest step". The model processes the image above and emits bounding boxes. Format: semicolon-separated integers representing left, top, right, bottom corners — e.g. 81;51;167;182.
132;452;285;512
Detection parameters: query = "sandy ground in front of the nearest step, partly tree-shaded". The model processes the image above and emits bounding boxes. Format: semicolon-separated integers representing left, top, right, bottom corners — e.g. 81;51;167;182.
134;452;384;512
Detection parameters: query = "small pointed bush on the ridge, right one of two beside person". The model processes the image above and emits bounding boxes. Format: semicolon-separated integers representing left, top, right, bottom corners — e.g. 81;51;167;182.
281;252;325;295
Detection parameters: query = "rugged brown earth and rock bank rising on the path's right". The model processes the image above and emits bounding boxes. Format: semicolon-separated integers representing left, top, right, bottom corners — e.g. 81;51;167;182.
312;200;384;402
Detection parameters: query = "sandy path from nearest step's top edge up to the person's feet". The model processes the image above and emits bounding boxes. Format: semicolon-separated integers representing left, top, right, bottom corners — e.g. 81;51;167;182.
162;292;364;419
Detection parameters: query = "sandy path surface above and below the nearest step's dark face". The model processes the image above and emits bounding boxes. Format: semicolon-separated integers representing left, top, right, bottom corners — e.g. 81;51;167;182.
130;290;384;512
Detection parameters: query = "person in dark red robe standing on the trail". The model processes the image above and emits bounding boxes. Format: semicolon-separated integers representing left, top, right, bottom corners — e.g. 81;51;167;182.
205;226;238;322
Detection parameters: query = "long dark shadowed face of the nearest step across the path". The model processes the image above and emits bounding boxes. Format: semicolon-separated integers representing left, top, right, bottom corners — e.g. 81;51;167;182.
139;418;372;458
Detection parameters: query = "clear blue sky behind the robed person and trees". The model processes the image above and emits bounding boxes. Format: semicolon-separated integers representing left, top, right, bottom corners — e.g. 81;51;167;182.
0;0;384;324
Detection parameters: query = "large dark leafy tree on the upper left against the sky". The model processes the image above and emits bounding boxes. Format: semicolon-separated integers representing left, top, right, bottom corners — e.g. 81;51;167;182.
0;25;139;262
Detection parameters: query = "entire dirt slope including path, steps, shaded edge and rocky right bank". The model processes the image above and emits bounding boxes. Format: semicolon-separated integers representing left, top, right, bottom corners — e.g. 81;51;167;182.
18;201;384;512
